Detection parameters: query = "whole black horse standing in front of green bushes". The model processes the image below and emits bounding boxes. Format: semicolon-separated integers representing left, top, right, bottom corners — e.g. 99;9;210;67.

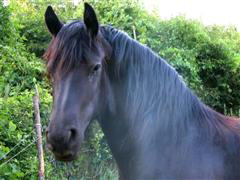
44;3;240;180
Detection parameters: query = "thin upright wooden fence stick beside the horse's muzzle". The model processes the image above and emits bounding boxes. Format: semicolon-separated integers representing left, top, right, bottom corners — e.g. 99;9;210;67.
33;85;44;180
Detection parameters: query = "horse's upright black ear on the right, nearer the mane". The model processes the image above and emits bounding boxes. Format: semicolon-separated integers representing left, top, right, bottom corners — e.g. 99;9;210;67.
83;3;99;38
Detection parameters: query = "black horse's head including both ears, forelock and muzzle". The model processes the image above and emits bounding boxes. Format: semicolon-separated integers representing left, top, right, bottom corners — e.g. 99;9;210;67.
44;3;111;161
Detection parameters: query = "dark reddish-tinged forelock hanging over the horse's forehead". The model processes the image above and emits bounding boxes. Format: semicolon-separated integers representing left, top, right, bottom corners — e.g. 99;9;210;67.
43;21;90;74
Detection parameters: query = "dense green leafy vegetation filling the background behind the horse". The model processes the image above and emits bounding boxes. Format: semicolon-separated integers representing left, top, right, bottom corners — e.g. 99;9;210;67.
0;0;240;180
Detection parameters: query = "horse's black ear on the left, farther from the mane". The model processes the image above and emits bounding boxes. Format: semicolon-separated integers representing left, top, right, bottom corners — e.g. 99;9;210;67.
45;6;63;36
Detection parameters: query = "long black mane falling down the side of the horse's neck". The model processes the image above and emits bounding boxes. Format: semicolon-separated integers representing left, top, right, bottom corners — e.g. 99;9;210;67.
102;26;240;139
